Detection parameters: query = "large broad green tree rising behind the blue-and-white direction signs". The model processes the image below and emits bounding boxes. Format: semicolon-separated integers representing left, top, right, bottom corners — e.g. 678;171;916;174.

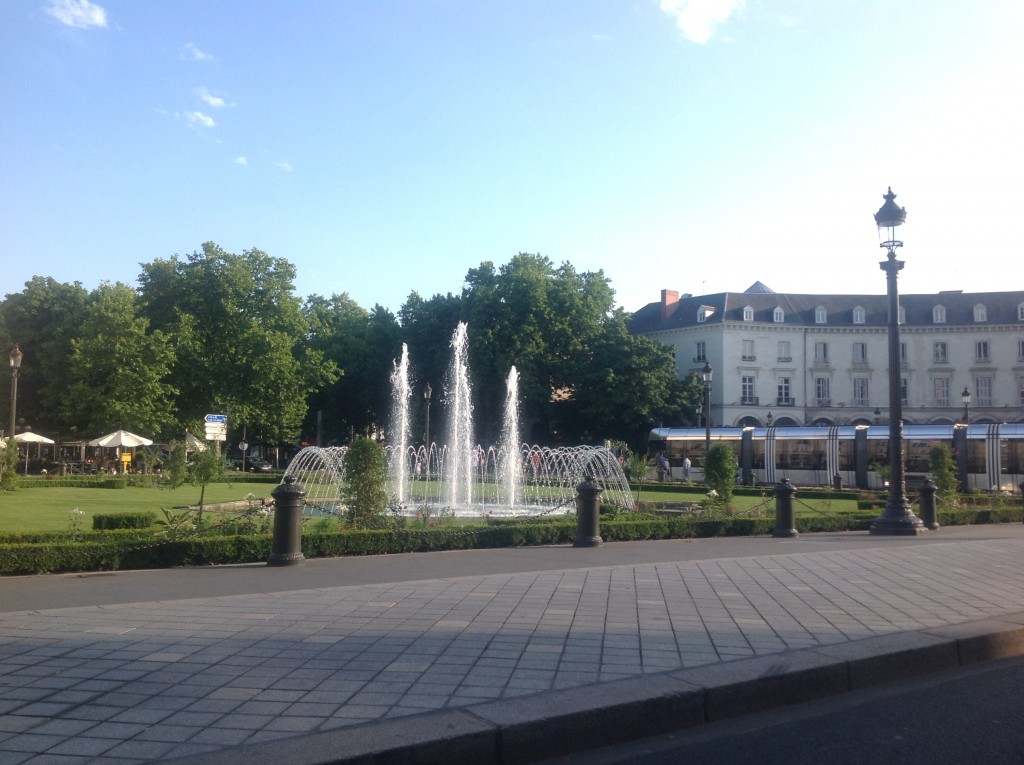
139;242;338;443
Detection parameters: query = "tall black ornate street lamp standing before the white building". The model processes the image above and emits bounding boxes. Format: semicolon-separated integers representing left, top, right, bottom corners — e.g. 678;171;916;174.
870;186;925;536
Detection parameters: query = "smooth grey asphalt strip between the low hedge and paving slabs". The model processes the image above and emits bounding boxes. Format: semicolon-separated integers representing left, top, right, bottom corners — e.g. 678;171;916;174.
0;523;1024;611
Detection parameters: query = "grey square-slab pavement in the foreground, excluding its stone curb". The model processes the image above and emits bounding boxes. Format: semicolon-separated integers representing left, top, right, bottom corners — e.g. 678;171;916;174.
0;537;1024;765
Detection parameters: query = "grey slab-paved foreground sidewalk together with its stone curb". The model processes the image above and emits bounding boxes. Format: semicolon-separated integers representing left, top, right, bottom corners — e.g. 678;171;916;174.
0;529;1024;765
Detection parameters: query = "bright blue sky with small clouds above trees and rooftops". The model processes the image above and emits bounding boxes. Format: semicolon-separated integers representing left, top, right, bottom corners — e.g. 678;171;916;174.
0;0;1024;310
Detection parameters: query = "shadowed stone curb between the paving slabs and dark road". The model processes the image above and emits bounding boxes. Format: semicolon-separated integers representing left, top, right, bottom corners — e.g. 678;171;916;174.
165;612;1024;765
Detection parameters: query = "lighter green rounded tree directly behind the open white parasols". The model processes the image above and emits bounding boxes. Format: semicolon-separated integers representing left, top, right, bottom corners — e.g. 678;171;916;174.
61;284;175;435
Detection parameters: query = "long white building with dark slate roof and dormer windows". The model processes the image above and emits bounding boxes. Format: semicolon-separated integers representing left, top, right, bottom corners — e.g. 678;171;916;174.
631;282;1024;426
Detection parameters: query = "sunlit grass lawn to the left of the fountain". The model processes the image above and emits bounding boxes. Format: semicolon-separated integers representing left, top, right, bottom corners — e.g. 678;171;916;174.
0;479;274;533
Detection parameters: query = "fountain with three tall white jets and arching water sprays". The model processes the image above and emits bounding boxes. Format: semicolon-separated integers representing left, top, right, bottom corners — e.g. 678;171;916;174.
285;324;633;517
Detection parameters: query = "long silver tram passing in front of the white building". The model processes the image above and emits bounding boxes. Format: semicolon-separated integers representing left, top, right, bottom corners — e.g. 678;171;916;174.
648;422;1024;492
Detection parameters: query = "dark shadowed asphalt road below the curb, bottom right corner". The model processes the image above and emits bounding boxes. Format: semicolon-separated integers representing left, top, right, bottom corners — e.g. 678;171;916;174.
538;657;1024;765
